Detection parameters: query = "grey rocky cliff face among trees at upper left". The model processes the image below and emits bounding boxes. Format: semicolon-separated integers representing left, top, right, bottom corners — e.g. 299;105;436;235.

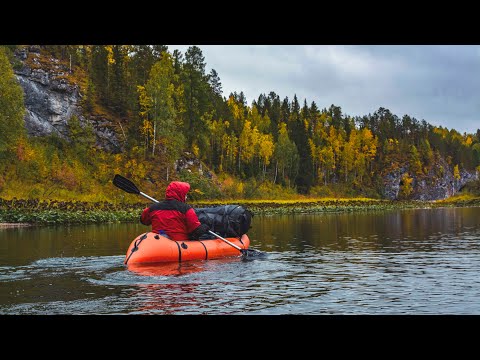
14;45;121;152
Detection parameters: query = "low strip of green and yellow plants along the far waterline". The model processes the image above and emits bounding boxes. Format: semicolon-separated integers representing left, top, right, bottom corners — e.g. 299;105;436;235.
0;196;480;228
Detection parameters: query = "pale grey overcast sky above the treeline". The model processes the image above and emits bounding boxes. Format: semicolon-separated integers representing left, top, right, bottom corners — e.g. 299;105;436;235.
168;45;480;134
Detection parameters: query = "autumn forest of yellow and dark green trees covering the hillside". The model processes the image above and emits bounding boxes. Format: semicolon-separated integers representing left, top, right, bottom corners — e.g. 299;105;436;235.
0;45;480;201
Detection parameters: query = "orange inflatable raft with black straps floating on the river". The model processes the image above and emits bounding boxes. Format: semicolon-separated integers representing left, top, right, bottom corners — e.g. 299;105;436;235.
124;232;250;265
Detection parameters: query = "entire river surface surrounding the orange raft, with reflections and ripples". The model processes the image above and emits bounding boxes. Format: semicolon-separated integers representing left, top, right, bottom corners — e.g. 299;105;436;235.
0;208;480;314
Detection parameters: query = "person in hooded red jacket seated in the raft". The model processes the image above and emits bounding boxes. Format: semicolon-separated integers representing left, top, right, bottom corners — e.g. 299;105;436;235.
140;181;209;240
